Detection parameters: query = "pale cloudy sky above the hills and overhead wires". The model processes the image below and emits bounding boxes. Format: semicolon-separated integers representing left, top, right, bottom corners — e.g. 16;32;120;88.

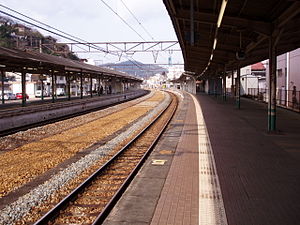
0;0;183;64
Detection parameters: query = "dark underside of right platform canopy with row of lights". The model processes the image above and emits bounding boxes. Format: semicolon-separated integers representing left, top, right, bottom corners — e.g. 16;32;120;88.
164;0;300;77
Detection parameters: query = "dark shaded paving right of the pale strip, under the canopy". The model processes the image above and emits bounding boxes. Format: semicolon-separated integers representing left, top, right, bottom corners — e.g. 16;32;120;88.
197;95;300;225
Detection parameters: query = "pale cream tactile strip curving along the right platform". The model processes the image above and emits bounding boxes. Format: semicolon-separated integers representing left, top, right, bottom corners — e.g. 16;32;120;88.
191;95;228;225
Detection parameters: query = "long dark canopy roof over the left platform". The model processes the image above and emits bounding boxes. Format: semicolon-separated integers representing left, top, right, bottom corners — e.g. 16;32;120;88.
0;47;142;82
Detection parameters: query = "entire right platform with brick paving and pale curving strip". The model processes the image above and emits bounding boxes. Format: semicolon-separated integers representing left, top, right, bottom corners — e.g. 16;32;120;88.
104;90;300;225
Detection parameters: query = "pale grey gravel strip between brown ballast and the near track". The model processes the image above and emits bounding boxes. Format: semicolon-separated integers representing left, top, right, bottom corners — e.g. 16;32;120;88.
0;91;171;224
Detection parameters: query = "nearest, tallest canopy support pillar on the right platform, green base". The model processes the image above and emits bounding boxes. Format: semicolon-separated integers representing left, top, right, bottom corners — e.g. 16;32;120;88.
268;37;277;131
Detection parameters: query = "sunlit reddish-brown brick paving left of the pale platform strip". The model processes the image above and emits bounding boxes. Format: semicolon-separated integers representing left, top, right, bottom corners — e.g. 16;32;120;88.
151;93;199;225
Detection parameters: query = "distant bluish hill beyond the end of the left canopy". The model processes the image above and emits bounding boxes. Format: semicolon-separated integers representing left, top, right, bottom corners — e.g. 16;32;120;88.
101;61;168;79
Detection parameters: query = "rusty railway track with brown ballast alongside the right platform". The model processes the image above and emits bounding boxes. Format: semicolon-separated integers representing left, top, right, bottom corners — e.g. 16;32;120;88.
31;94;177;225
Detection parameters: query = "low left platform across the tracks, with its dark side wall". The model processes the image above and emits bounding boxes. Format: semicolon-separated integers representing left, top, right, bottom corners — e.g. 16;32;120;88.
0;90;149;135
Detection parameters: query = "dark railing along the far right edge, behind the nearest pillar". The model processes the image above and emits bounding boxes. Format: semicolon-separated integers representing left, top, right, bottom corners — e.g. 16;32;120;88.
248;88;300;112
